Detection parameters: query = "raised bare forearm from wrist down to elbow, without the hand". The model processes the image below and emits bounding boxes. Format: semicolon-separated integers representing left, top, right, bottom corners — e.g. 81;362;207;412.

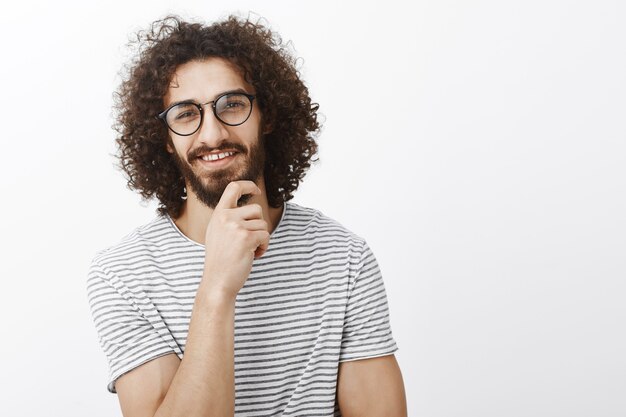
155;284;235;417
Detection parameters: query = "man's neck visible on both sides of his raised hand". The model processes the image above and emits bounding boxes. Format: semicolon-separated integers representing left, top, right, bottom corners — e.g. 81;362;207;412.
172;180;283;245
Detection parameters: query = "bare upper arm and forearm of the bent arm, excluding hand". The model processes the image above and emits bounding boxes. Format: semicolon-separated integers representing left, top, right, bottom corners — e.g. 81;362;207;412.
116;288;235;417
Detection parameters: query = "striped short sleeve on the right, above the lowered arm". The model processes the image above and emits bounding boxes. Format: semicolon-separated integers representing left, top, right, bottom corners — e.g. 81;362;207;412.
339;243;398;362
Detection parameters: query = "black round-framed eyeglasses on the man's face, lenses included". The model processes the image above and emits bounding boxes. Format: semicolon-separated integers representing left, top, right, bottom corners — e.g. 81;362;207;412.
156;93;255;136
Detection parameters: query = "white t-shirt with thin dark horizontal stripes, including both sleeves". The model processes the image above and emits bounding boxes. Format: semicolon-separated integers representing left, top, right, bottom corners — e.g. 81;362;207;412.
87;202;397;416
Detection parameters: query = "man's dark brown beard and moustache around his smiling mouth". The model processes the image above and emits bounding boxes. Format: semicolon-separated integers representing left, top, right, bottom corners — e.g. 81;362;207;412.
171;135;265;209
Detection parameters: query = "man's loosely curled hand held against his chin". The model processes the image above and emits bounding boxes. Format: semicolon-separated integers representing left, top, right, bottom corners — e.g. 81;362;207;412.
203;181;270;298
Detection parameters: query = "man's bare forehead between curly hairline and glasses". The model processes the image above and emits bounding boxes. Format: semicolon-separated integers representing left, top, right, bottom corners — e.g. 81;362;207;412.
163;58;254;107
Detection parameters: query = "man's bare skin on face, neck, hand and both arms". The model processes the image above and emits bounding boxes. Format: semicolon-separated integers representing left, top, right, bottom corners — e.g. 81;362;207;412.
116;58;407;417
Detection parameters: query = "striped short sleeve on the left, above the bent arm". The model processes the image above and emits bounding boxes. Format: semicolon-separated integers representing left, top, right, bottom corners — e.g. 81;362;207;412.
87;261;175;393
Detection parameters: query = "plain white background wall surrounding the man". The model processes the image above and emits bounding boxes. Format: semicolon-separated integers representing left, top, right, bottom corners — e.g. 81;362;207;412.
0;0;626;417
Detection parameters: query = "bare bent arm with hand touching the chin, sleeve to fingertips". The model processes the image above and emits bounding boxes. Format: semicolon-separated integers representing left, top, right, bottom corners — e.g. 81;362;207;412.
116;181;269;417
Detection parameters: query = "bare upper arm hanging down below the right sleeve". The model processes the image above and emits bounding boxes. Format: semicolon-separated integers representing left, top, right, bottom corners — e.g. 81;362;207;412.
337;355;407;417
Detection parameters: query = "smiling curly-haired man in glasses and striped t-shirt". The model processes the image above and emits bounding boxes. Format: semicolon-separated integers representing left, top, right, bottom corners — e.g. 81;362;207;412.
87;13;406;417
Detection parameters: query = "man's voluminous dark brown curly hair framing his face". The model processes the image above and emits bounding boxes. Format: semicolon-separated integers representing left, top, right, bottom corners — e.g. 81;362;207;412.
113;16;320;218
